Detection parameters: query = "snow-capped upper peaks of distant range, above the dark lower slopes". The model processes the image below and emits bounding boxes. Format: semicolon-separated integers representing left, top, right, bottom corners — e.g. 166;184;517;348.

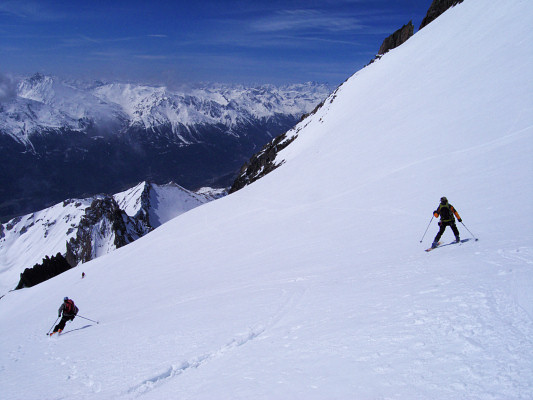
0;73;330;148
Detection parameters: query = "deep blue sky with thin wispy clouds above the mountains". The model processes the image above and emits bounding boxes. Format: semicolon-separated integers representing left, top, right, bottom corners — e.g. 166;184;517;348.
0;0;431;84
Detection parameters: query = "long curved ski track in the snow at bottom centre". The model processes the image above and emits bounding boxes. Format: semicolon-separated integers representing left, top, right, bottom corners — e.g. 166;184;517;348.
124;288;306;397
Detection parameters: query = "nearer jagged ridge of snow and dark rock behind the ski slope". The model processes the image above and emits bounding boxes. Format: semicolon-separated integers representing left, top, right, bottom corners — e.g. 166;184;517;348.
0;182;224;295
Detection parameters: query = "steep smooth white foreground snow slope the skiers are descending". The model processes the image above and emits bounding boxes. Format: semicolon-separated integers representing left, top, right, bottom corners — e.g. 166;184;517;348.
0;0;533;399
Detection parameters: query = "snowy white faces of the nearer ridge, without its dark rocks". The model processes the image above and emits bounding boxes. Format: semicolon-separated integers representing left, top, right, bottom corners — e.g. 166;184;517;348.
0;182;214;296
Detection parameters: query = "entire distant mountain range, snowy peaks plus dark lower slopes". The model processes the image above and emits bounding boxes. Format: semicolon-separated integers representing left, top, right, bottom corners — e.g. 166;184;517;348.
0;74;330;218
